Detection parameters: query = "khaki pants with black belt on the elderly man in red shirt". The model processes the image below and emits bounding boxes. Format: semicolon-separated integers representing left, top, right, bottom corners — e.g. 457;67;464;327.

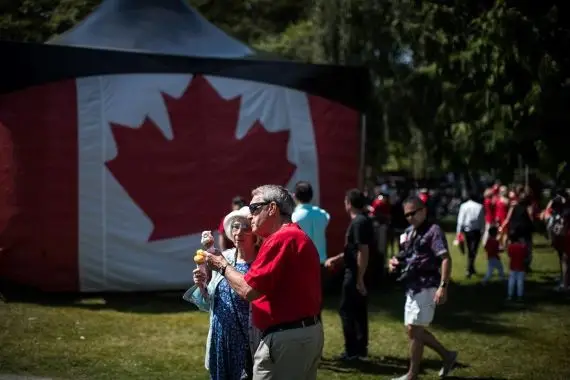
253;322;324;380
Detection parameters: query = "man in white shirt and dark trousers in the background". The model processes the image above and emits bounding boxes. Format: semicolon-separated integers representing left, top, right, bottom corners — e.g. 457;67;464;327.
457;194;485;278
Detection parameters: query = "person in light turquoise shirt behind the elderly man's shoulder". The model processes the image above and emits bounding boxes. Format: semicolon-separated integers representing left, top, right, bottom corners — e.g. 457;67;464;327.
291;181;330;266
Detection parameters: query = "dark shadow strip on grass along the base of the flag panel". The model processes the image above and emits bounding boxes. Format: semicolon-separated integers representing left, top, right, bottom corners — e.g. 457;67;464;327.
0;283;197;314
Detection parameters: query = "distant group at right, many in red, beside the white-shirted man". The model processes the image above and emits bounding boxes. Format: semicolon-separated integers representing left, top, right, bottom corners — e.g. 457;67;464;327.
455;183;570;300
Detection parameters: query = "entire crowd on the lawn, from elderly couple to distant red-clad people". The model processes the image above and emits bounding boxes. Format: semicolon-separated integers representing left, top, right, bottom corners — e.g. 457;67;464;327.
184;181;570;380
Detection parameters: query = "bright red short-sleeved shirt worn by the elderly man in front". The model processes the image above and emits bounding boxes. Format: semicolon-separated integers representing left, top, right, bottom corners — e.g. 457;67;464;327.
245;224;321;330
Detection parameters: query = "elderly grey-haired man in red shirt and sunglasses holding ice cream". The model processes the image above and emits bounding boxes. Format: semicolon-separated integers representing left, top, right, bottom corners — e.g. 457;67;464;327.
207;185;324;380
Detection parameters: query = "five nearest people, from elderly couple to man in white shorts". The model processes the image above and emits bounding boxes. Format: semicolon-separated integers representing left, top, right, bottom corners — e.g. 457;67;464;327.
184;181;457;380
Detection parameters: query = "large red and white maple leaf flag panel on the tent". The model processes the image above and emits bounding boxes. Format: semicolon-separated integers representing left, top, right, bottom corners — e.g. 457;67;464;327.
0;74;359;291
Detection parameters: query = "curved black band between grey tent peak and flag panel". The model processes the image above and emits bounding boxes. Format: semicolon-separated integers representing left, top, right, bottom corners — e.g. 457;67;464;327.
0;41;369;112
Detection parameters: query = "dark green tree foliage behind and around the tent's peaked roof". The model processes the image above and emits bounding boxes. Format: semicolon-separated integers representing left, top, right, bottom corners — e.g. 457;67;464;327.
0;0;570;183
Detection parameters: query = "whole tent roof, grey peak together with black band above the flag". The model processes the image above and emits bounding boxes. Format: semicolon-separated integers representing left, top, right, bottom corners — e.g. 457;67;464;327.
0;0;370;110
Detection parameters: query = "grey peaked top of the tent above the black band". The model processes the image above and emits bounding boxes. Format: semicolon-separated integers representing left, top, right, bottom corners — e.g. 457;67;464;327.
48;0;255;58
